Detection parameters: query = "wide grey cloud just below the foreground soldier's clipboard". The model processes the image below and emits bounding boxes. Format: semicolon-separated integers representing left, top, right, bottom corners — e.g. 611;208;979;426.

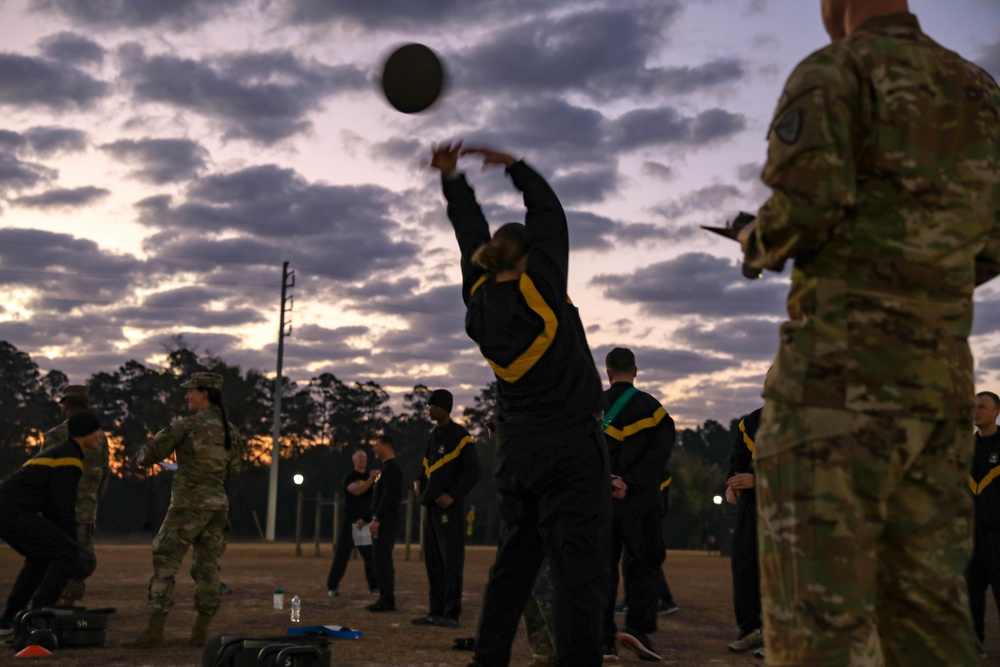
591;252;788;318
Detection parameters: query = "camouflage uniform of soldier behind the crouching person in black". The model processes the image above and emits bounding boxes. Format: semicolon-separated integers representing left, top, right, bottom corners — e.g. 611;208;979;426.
42;422;111;604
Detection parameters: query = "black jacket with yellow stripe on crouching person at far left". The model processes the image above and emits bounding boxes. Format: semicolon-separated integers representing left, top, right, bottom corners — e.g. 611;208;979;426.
0;440;83;542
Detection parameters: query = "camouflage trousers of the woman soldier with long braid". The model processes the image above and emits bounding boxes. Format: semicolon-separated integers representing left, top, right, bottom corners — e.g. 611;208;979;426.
146;506;229;616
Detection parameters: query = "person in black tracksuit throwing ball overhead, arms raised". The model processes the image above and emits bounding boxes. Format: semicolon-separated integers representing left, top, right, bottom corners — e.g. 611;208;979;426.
431;143;611;667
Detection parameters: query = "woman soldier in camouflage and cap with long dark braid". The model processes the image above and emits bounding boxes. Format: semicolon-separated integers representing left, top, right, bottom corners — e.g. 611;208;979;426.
130;373;243;648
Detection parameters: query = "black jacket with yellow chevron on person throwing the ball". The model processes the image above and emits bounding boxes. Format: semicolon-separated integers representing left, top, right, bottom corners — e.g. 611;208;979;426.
443;162;604;437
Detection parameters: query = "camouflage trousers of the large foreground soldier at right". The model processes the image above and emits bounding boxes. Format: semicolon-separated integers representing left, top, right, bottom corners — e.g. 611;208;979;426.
756;401;979;667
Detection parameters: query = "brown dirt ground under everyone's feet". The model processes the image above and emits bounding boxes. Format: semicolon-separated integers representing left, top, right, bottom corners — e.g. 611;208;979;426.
0;544;1000;667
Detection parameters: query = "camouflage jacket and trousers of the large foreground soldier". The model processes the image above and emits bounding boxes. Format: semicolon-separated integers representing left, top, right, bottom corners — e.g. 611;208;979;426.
744;13;1000;666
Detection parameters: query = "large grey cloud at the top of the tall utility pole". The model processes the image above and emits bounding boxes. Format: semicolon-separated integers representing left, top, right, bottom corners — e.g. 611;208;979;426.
136;165;418;281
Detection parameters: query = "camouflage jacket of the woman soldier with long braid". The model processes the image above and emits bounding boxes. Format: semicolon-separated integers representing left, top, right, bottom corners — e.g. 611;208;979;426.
136;405;243;510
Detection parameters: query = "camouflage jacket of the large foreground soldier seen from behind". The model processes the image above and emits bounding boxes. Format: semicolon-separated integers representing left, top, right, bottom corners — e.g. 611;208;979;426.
744;13;1000;420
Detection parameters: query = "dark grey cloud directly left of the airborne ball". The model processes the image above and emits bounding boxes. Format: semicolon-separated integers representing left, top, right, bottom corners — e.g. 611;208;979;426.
119;44;369;145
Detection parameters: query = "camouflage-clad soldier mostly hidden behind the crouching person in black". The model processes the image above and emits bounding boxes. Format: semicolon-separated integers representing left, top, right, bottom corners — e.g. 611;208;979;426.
42;384;111;605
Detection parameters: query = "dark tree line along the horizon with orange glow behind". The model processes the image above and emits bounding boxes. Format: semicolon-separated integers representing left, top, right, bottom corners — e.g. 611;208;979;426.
0;337;738;548
